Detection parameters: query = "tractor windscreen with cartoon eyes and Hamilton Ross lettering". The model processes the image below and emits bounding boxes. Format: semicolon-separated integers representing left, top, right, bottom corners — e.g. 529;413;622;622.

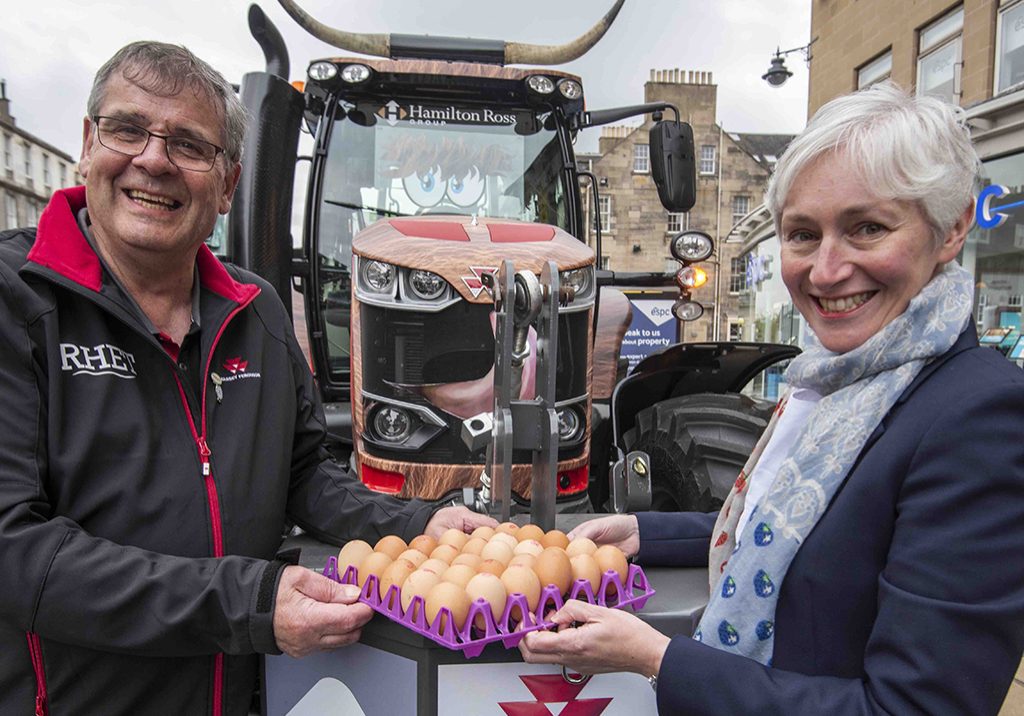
313;100;570;391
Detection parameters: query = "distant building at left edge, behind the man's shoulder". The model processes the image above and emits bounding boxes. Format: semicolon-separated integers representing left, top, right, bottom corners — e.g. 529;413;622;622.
0;81;82;230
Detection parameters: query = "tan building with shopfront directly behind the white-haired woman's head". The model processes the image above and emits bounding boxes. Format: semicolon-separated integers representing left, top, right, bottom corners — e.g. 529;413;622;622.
734;0;1024;368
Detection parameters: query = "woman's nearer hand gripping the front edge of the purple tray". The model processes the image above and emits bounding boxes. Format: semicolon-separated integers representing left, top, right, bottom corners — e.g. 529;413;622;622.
519;599;670;676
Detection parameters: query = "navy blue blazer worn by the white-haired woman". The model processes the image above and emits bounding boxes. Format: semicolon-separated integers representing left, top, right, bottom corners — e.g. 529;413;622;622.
638;326;1024;716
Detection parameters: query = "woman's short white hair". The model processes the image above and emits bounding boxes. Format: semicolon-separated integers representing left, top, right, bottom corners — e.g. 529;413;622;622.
765;82;981;242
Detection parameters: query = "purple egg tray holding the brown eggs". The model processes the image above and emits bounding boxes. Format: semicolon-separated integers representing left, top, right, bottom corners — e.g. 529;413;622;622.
324;557;654;659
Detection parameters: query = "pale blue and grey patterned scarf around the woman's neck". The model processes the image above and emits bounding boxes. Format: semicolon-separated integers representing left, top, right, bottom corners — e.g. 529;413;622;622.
693;262;974;666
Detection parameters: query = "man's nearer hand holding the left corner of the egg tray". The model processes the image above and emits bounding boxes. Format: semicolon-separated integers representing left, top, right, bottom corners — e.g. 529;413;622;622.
273;565;374;658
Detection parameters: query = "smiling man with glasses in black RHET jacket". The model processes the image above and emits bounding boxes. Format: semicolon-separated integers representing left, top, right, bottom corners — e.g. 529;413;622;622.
0;42;494;714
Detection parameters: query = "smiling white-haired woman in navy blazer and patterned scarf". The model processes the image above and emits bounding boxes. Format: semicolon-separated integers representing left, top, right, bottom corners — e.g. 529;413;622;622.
520;84;1024;714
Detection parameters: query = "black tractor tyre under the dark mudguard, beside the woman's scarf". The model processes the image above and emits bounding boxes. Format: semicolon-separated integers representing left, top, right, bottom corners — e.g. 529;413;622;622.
623;393;773;512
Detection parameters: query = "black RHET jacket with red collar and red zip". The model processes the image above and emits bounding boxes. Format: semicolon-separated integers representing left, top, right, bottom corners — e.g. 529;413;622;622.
0;187;432;715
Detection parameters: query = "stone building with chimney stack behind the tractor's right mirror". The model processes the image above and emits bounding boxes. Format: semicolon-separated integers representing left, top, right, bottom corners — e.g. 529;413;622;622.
584;69;792;342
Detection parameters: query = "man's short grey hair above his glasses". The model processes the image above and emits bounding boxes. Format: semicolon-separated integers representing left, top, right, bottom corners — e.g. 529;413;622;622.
87;40;249;164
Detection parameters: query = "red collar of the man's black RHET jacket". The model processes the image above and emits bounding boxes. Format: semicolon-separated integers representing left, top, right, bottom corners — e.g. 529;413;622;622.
28;186;259;303
